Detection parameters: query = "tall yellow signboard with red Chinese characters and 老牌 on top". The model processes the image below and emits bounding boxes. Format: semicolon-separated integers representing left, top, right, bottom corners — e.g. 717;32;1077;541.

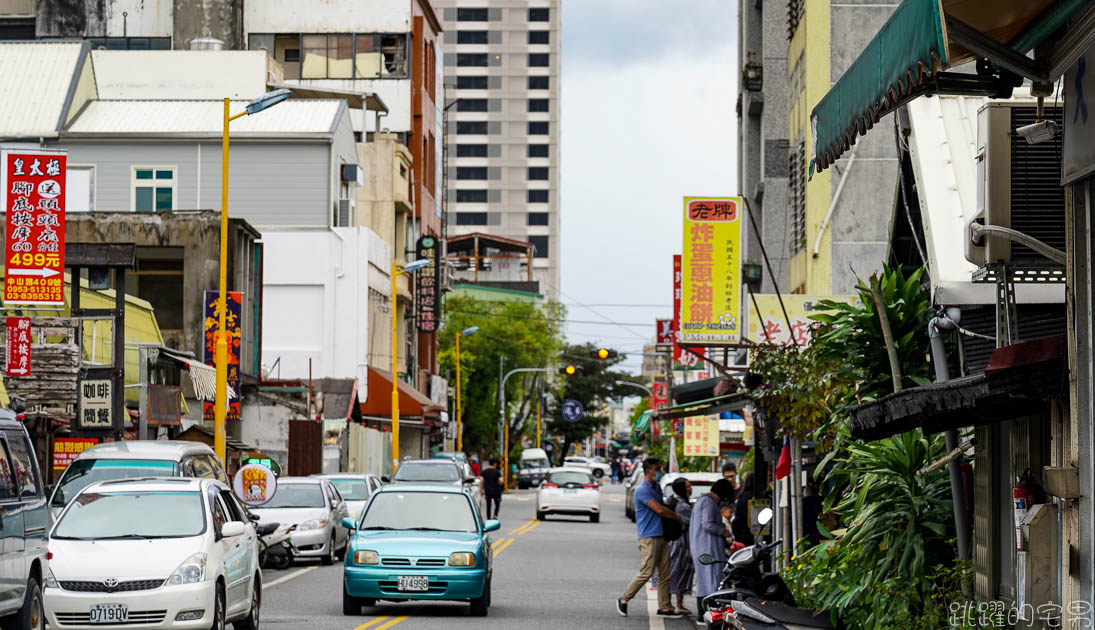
680;197;742;345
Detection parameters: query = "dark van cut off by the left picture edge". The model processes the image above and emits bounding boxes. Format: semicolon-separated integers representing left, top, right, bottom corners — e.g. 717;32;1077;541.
0;409;49;630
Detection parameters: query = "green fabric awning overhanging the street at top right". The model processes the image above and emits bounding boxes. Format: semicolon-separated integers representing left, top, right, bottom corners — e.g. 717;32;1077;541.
810;0;1077;172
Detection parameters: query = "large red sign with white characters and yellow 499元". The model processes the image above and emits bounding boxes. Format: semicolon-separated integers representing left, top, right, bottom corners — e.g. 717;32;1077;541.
0;151;68;306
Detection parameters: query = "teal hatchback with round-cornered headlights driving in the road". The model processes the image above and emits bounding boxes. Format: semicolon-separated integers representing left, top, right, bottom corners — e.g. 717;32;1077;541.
343;484;500;617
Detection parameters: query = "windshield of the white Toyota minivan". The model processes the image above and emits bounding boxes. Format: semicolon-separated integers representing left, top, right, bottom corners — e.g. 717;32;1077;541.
53;492;205;540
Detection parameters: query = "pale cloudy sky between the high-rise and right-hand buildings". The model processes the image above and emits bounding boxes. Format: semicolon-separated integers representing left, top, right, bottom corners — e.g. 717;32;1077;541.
560;0;738;374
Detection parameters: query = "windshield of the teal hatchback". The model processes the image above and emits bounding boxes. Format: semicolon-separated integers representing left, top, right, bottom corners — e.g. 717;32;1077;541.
358;492;477;531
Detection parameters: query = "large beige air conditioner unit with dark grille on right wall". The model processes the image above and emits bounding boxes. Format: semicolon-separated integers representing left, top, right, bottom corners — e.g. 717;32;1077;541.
965;101;1065;266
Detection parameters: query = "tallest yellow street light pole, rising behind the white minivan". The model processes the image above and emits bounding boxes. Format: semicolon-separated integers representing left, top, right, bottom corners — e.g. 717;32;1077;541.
214;89;289;468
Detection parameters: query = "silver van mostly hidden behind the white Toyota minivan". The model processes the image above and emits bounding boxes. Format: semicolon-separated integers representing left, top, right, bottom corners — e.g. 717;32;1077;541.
49;439;231;519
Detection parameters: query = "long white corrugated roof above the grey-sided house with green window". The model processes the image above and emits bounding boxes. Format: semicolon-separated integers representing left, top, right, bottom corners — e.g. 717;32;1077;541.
65;99;345;137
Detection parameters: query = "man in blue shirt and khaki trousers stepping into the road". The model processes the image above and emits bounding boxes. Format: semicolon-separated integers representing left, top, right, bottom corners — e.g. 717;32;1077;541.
616;457;681;619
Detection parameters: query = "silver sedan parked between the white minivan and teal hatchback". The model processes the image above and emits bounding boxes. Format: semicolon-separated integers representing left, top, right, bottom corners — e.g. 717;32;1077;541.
251;477;349;564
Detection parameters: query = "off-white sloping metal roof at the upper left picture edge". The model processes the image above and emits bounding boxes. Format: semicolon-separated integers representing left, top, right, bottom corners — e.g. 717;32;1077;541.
0;42;83;138
